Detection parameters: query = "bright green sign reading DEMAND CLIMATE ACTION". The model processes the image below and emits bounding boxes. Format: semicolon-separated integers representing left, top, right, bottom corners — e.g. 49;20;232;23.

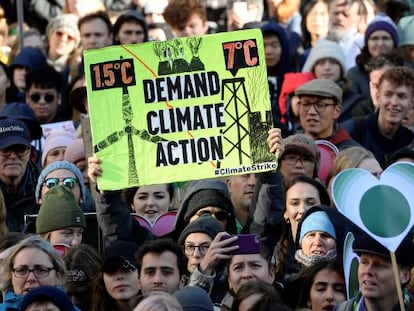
84;29;277;190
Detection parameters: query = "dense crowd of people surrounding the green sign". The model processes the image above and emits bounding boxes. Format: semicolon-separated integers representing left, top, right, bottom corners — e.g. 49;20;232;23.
0;0;414;311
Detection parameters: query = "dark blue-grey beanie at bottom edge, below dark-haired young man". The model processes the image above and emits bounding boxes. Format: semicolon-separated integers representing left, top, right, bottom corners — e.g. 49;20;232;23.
173;286;214;311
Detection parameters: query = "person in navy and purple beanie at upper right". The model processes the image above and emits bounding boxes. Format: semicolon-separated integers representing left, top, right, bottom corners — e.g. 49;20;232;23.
347;14;399;99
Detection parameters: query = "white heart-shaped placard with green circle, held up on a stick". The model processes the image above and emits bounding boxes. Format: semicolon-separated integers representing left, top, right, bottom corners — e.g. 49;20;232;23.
332;162;414;252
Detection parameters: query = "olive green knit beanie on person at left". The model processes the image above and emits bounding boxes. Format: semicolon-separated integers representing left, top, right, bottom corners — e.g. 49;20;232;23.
36;186;86;234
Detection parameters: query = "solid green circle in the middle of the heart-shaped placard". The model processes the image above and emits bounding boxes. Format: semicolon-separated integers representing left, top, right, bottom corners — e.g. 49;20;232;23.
359;185;411;238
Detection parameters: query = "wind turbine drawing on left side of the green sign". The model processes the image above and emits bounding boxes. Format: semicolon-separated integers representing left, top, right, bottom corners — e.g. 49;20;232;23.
94;86;166;185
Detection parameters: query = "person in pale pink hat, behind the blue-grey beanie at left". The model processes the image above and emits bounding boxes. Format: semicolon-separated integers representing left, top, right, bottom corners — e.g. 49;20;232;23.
42;128;76;167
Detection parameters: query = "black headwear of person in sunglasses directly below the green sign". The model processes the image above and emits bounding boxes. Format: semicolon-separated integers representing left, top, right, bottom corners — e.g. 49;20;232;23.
184;189;234;223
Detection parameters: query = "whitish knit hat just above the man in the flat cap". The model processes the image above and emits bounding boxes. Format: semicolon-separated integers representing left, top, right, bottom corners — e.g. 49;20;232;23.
302;39;346;75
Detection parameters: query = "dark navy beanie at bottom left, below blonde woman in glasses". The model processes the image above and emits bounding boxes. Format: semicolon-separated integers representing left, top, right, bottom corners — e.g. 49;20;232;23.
20;285;75;311
